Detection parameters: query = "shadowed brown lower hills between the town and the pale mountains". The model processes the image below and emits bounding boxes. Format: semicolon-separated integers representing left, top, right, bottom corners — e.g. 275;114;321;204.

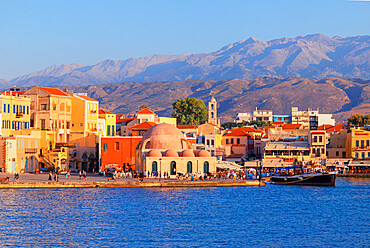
59;77;370;122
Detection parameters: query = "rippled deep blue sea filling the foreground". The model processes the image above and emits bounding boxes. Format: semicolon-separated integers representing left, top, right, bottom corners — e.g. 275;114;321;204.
0;179;370;247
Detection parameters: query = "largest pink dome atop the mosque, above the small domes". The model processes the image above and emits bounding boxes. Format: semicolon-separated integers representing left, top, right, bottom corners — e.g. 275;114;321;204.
142;123;185;150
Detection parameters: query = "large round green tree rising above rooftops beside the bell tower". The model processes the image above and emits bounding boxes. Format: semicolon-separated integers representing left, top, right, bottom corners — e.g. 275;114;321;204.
172;97;207;125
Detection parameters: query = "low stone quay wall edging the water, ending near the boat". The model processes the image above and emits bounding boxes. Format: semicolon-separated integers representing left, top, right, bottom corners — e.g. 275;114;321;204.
0;180;265;189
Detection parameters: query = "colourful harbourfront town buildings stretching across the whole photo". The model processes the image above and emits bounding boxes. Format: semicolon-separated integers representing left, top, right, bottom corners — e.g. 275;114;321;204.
0;86;370;175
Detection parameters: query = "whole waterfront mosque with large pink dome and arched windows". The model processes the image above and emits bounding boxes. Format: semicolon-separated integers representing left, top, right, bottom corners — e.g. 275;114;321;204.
135;123;216;178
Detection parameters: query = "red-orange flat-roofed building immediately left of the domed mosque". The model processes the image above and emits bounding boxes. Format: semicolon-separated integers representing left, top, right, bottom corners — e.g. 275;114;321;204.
100;136;142;171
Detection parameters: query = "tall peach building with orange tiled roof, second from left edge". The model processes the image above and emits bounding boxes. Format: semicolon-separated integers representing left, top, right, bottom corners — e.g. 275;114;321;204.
23;86;72;143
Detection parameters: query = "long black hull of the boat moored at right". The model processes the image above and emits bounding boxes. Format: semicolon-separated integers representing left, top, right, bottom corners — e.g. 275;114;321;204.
270;174;335;186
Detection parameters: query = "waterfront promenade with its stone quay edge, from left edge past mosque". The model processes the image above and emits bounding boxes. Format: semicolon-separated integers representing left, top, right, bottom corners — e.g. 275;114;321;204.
0;173;265;189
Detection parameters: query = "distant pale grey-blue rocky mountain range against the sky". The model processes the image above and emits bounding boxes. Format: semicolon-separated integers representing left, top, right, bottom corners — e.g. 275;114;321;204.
5;34;370;87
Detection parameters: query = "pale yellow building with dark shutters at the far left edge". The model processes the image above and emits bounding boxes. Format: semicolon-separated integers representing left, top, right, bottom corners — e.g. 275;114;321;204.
0;91;31;136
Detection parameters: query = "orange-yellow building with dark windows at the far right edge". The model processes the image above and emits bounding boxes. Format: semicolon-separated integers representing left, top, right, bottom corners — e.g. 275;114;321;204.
346;128;370;160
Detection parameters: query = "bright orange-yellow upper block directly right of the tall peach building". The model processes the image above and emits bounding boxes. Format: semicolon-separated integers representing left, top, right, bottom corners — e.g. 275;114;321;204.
71;94;99;133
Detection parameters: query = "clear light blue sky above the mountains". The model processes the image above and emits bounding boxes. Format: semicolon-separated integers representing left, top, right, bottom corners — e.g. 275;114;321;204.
0;0;370;80
